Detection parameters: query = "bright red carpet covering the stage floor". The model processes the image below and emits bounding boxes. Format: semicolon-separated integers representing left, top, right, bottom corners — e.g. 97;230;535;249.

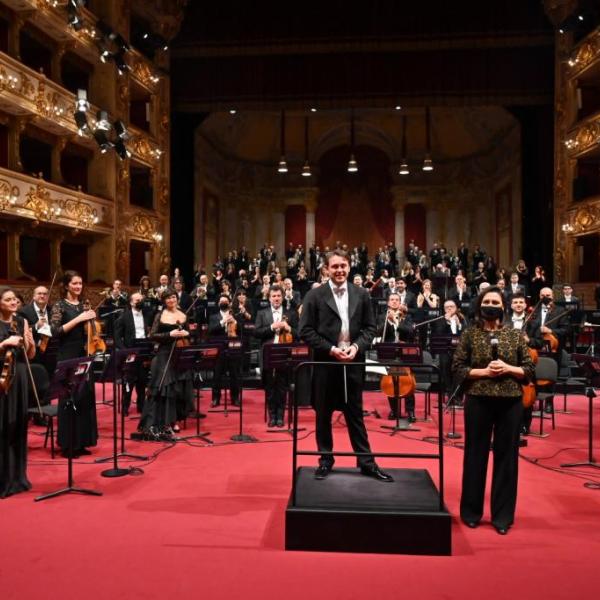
0;392;600;600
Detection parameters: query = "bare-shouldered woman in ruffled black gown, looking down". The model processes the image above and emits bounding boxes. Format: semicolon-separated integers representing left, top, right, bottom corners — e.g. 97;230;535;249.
139;288;193;441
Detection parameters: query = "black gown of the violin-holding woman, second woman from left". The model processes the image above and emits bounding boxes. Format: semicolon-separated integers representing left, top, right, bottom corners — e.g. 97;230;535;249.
51;299;98;450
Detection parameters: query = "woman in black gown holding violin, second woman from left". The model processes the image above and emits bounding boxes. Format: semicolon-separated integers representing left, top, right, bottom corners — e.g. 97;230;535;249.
50;271;98;458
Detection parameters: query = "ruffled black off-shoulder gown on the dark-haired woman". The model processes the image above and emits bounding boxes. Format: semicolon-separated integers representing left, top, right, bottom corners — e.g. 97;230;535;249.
139;314;194;438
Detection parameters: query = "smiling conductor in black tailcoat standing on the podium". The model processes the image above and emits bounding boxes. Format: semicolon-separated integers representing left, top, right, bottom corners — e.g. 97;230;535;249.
300;249;393;482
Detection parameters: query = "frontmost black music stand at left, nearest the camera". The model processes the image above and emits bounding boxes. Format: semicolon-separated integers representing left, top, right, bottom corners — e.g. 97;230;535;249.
34;356;102;502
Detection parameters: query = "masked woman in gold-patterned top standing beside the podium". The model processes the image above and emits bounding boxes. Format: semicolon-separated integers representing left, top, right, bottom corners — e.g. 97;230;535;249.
452;287;535;535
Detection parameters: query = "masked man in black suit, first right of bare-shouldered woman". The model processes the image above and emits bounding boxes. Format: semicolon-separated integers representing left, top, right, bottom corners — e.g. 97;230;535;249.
208;294;242;408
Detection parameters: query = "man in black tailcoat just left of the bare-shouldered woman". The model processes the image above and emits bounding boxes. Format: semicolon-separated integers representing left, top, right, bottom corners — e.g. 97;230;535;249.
115;292;150;416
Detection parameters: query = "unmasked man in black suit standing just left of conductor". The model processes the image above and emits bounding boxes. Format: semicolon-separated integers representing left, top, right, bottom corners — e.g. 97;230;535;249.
254;285;298;427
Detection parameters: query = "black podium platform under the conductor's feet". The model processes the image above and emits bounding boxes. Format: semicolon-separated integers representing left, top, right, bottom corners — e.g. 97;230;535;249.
285;467;452;555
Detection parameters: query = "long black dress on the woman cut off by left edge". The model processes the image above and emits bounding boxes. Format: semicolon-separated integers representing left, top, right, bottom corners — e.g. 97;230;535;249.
0;316;31;498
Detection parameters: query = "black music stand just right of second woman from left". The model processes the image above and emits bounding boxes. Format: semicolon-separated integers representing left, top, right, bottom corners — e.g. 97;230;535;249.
95;348;148;477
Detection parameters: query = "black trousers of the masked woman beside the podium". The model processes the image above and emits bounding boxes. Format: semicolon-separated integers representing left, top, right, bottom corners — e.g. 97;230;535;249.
460;396;523;527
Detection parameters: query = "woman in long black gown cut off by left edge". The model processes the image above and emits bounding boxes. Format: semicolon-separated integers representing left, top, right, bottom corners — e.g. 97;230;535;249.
0;287;35;498
